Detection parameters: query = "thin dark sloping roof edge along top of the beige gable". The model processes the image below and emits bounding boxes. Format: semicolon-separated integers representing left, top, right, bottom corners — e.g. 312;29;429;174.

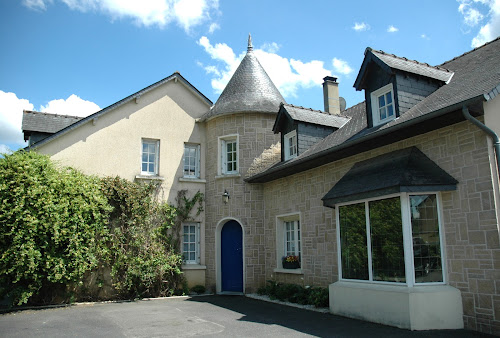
27;72;212;149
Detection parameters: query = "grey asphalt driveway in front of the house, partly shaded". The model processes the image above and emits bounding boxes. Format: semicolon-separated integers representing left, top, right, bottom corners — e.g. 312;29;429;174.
0;296;490;337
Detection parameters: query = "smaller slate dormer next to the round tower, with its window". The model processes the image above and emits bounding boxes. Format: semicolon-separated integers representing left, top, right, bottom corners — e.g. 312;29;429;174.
273;103;349;161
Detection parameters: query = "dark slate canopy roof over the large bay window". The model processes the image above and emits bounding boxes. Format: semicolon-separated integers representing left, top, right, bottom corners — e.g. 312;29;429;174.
322;147;458;207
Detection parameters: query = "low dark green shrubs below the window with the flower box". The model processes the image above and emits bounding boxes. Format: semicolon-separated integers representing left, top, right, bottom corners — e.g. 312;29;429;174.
257;280;329;307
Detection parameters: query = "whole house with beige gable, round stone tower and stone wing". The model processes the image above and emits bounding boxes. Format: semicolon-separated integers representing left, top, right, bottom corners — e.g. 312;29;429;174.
25;39;500;334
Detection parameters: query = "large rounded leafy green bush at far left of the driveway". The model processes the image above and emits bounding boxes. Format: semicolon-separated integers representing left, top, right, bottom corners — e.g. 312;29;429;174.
0;151;111;305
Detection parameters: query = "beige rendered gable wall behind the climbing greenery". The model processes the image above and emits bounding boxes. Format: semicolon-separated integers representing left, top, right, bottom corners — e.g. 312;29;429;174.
37;80;210;285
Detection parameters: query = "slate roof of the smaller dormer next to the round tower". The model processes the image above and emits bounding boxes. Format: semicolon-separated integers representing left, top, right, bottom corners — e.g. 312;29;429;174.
280;104;350;128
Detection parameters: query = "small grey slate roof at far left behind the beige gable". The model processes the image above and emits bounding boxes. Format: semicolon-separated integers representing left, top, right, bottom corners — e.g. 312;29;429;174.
22;110;83;134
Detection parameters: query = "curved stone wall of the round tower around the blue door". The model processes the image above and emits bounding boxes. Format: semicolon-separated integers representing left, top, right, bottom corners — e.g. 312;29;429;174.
205;113;279;292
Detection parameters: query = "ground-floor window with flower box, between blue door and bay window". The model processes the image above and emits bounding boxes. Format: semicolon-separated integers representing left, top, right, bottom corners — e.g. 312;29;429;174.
276;213;302;273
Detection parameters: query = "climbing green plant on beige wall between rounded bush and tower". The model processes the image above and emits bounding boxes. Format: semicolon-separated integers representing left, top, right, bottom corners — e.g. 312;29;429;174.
102;177;182;298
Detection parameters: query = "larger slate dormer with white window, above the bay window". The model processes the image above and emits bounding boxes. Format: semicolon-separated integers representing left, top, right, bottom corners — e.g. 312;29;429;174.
354;48;453;128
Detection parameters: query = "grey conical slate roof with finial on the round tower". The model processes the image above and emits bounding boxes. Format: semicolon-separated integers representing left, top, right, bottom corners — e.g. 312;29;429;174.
205;36;286;119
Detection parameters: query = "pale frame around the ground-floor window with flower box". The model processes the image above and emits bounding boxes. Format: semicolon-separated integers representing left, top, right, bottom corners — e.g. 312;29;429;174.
276;212;303;269
